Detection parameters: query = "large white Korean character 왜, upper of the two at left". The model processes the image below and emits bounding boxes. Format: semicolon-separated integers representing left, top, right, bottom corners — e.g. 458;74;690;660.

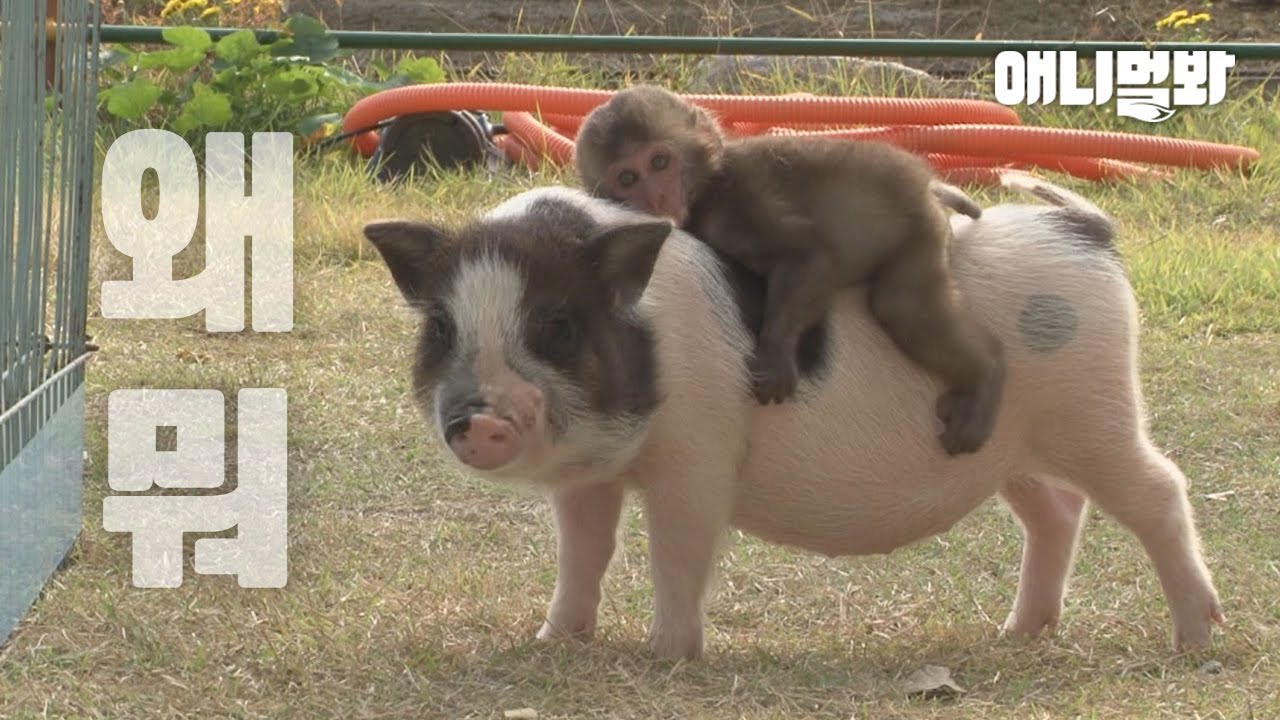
101;129;293;332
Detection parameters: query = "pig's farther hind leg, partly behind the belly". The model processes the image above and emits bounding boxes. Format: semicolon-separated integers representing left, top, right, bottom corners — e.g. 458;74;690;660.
1000;477;1084;635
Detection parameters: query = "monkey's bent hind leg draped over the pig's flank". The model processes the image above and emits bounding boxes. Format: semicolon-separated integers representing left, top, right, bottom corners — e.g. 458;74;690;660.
870;236;1005;455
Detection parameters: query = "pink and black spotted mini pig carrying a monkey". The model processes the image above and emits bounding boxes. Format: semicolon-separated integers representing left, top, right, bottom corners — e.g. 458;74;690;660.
365;177;1222;659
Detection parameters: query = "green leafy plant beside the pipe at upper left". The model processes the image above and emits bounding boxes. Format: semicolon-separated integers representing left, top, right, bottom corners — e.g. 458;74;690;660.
99;15;444;140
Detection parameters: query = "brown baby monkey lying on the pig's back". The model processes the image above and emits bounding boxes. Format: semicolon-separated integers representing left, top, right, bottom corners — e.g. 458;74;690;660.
575;85;1005;455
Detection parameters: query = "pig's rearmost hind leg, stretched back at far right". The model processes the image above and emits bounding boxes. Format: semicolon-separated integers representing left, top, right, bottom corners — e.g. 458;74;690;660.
1064;434;1224;650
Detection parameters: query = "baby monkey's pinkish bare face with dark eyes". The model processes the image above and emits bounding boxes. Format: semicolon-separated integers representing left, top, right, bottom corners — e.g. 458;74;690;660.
604;142;689;225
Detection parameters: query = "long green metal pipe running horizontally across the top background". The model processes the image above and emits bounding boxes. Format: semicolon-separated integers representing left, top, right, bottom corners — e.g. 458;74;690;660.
101;26;1280;59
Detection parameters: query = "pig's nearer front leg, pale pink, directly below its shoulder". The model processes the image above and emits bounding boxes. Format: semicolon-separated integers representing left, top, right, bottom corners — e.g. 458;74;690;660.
644;462;732;660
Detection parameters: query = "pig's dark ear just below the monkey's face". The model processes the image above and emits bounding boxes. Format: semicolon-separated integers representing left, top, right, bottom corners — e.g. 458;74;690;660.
586;220;675;305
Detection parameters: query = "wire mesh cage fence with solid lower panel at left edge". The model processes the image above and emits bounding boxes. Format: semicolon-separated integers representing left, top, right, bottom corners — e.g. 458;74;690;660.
0;0;100;641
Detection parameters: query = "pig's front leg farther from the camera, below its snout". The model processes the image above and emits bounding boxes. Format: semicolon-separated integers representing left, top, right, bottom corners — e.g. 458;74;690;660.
538;483;622;639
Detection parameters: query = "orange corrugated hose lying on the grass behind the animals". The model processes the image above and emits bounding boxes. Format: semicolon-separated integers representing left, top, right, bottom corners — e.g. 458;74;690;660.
343;83;1258;183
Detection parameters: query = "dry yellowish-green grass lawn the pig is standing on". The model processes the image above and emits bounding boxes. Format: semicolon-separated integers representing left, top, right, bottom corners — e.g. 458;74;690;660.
0;63;1280;720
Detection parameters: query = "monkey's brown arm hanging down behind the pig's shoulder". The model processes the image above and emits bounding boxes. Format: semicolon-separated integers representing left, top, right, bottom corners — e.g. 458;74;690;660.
750;252;837;404
